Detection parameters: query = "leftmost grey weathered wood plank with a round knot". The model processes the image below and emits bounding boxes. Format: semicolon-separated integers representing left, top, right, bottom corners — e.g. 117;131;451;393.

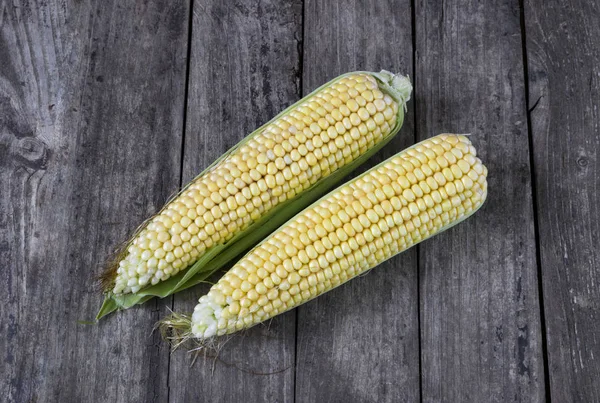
0;0;188;402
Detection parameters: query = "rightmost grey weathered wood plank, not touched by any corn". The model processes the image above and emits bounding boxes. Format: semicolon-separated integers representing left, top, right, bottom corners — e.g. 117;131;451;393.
525;0;600;403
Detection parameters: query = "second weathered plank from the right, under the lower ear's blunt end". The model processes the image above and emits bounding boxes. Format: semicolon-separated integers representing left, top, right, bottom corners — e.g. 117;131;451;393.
415;0;544;402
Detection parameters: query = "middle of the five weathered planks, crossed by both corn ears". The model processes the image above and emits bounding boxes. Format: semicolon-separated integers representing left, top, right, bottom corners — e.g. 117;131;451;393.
296;0;419;402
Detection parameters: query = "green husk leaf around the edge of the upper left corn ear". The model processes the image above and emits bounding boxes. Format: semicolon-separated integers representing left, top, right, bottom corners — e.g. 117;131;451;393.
96;71;412;320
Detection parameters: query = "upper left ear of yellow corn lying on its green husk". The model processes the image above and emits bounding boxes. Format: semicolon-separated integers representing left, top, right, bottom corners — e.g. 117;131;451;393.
97;71;412;319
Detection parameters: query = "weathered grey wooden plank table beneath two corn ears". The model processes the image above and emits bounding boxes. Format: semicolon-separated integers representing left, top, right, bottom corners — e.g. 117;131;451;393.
0;0;600;403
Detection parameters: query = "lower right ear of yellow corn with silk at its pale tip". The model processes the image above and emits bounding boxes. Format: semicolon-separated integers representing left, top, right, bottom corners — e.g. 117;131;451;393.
162;134;487;343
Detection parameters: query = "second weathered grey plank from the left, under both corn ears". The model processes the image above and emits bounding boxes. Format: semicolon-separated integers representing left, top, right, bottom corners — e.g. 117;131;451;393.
169;0;302;402
